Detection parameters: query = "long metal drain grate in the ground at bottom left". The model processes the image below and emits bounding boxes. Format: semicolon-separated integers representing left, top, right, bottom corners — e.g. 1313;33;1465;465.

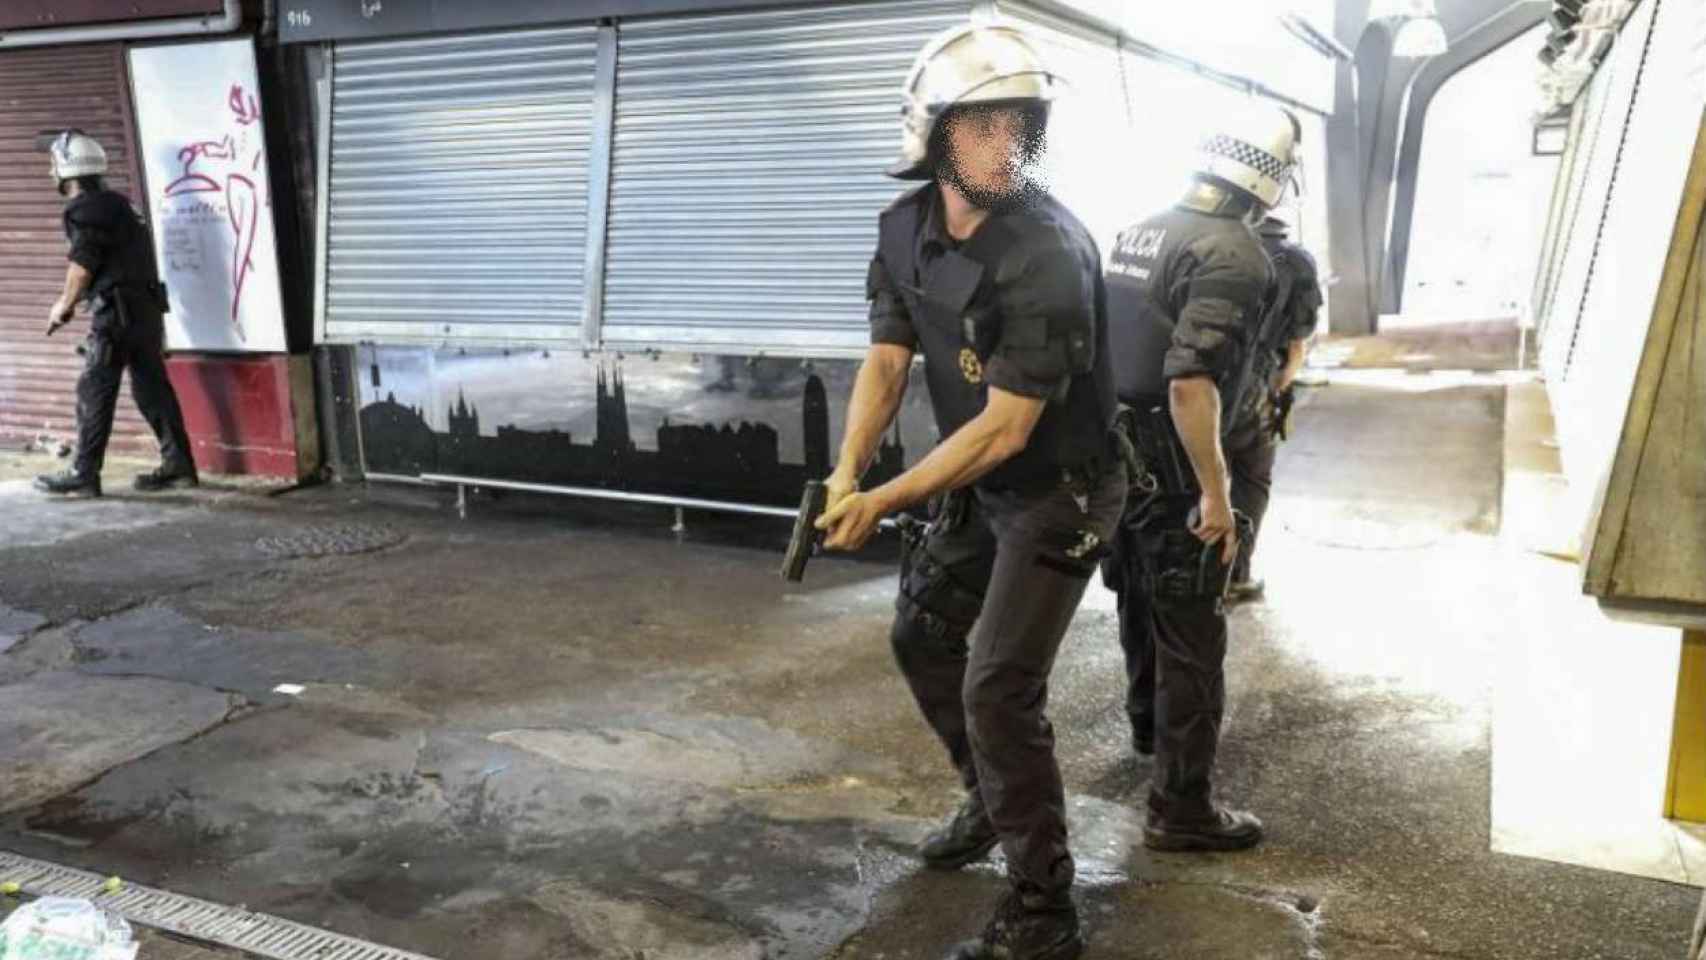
0;851;446;960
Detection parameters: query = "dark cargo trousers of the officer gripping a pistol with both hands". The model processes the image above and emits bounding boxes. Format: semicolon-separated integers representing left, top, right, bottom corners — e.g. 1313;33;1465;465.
892;469;1126;893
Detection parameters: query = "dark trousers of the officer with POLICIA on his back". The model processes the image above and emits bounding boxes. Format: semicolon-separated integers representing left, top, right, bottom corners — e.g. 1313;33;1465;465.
1111;494;1227;825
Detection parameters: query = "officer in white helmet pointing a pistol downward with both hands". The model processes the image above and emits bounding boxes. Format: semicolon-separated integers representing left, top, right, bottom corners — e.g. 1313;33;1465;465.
819;26;1126;960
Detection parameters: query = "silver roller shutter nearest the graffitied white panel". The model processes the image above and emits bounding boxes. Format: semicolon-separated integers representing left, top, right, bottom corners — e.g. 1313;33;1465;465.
324;26;597;343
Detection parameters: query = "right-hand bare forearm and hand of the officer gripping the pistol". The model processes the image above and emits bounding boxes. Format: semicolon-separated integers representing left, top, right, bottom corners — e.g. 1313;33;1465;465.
870;387;1044;513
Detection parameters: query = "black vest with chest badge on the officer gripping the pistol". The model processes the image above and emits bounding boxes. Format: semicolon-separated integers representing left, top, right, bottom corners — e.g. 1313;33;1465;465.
877;184;1116;489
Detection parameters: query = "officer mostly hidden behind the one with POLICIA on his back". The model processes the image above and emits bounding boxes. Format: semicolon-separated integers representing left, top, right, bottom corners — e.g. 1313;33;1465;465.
1227;215;1326;604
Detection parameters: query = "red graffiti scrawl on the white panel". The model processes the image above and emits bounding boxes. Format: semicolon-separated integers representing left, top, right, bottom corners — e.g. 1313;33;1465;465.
164;84;271;339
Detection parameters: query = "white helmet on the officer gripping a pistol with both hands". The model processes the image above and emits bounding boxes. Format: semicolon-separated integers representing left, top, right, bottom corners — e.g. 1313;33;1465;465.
889;24;1061;181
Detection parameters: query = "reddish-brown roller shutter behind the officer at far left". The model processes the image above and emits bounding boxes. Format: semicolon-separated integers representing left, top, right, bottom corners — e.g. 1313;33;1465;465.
0;44;154;450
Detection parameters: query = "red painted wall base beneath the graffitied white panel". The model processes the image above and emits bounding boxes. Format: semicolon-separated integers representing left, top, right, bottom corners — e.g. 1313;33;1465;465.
165;353;319;479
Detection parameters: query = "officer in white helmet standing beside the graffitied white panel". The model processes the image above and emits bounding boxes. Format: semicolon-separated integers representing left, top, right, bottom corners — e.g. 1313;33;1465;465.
36;130;198;496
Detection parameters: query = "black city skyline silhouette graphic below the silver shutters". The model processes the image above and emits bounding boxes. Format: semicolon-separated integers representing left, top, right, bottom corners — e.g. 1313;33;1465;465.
362;363;906;506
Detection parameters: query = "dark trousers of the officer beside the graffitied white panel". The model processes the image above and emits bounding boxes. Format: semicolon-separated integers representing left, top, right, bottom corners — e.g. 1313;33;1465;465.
73;317;193;476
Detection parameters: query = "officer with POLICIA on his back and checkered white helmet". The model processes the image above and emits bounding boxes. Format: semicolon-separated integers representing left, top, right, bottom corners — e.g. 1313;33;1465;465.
1104;109;1300;851
